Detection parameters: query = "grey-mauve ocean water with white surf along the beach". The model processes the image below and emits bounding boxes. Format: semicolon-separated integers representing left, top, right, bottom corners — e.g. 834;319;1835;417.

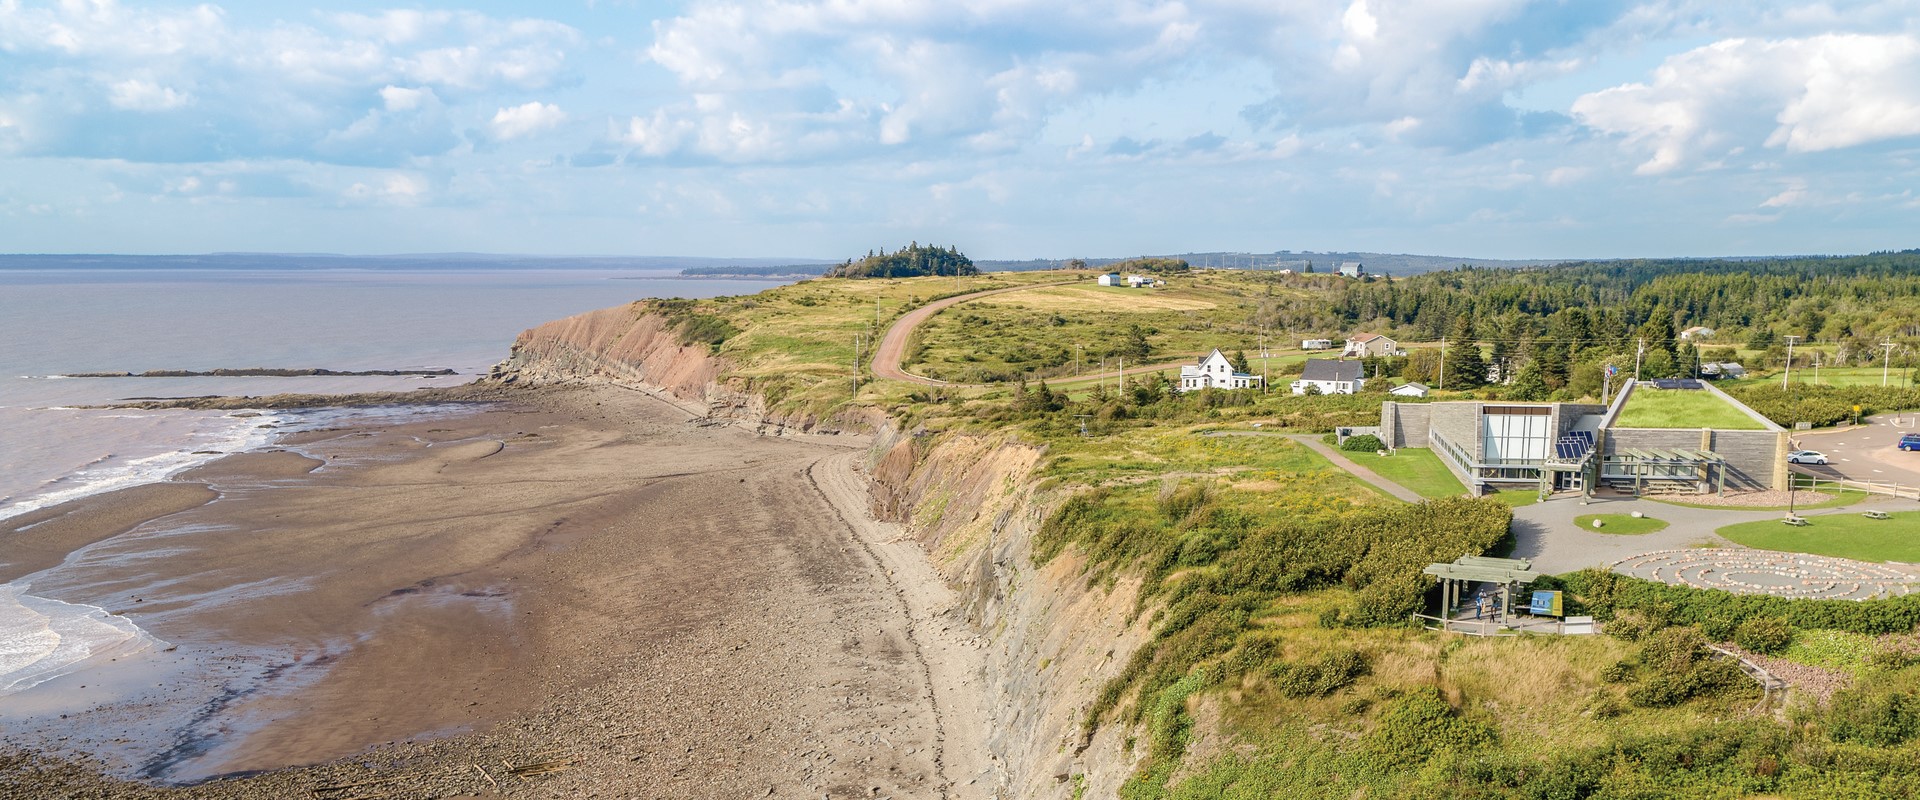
0;269;780;700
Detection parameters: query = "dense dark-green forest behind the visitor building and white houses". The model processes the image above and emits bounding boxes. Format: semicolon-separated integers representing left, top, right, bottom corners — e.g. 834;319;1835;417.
1258;251;1920;399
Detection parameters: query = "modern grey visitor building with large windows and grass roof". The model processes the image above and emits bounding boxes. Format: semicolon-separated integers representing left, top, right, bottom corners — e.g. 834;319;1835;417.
1380;380;1788;497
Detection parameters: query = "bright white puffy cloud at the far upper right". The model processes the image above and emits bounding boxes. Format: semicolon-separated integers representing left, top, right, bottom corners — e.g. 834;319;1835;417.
1572;33;1920;175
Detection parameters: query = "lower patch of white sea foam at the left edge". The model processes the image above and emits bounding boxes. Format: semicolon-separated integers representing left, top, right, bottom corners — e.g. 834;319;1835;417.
0;583;161;696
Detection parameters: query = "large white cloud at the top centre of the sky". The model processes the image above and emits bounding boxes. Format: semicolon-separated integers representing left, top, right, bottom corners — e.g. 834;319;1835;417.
622;0;1202;161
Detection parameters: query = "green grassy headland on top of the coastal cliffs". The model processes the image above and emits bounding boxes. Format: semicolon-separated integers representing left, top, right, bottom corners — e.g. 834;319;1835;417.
633;272;1920;798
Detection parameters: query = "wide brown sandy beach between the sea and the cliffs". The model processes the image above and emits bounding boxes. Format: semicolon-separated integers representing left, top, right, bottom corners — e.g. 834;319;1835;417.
0;388;993;798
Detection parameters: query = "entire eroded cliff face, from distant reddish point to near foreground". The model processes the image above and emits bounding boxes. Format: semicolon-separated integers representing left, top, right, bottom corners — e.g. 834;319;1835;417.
492;303;1148;798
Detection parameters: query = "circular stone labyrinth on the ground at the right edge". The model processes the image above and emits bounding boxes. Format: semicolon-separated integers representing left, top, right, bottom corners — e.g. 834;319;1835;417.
1613;549;1920;600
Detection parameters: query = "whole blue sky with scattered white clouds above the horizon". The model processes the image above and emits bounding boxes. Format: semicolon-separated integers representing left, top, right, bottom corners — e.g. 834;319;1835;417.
0;0;1920;259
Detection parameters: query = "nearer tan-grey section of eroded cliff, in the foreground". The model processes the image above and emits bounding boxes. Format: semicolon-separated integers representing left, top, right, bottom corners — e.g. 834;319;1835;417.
870;428;1148;798
